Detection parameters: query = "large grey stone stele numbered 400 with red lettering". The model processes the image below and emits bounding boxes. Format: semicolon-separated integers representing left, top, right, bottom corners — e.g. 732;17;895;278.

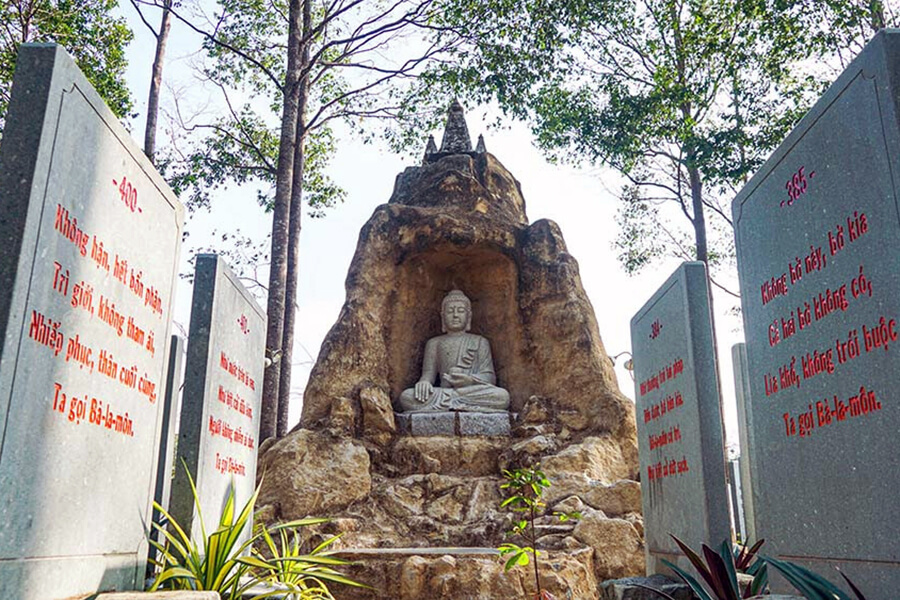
0;44;183;600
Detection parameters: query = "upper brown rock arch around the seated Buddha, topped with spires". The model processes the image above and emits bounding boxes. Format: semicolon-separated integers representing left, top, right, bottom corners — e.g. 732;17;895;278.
301;99;634;446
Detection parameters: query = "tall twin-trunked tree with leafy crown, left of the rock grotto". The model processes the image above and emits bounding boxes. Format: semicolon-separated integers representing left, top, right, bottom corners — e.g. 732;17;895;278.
156;0;454;439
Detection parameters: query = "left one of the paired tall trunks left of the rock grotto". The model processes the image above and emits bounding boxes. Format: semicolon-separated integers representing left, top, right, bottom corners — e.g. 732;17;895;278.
259;0;302;443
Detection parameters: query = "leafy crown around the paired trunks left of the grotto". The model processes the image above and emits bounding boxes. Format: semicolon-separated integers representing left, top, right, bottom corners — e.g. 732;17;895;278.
161;0;458;223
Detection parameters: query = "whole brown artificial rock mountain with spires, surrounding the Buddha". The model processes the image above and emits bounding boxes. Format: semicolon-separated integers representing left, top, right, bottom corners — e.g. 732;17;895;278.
259;103;643;600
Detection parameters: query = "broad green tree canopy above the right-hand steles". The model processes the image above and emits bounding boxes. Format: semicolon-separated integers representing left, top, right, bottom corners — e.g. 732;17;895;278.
410;0;900;280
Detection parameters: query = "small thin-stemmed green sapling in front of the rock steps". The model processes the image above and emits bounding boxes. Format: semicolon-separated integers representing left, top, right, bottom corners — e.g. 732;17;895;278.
497;465;581;600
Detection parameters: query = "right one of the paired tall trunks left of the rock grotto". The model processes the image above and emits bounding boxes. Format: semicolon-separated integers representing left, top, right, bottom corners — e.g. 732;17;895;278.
276;0;312;437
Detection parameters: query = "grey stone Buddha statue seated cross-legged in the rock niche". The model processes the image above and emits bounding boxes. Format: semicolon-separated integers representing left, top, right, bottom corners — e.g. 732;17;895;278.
399;290;509;412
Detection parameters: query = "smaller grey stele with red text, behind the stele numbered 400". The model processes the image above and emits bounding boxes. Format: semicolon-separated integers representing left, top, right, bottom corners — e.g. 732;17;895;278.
169;254;266;539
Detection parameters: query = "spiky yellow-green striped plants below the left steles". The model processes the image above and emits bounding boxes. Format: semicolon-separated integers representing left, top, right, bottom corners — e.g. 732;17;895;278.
148;466;365;600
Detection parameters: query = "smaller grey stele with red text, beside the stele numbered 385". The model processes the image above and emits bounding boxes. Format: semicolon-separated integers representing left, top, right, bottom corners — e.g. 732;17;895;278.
631;262;731;575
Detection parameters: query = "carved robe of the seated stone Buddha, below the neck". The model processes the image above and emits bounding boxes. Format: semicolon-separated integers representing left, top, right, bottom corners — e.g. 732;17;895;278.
399;333;509;412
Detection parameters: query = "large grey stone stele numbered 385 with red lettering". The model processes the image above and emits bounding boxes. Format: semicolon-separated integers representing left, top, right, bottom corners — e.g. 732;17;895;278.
732;29;900;600
